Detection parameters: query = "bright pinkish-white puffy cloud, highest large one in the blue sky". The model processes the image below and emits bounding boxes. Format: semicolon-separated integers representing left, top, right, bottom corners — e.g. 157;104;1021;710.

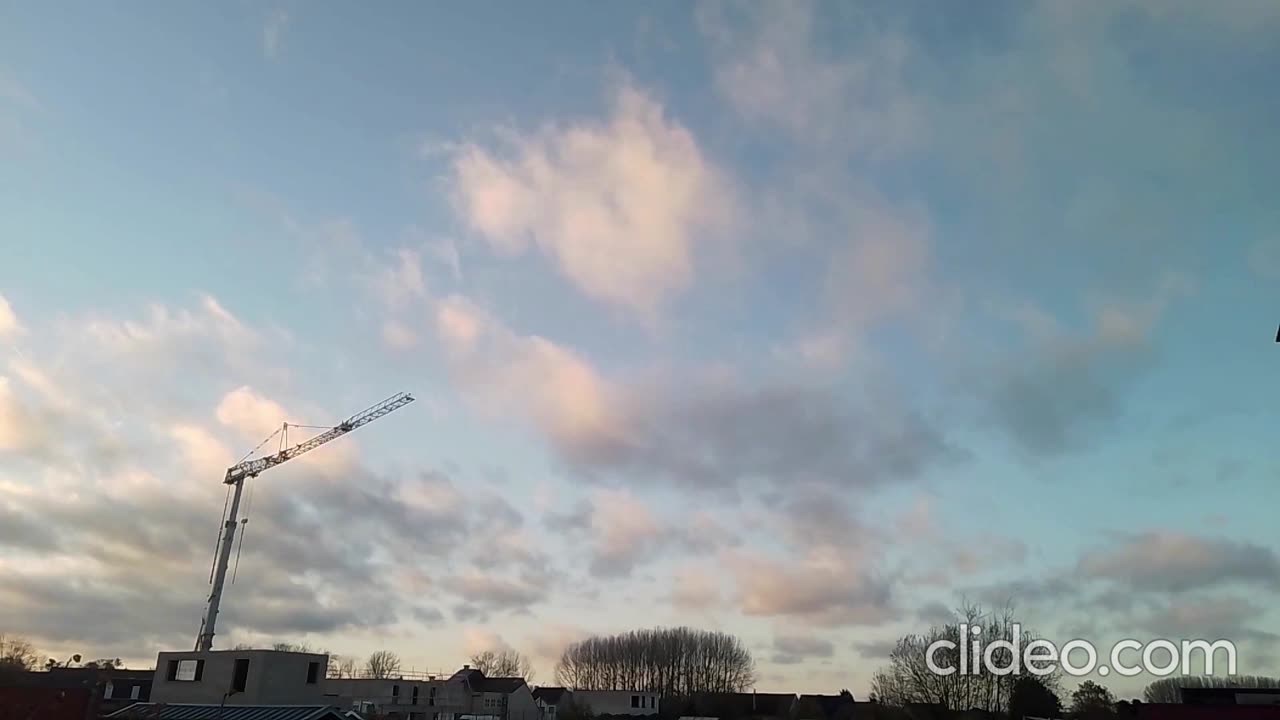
451;86;733;319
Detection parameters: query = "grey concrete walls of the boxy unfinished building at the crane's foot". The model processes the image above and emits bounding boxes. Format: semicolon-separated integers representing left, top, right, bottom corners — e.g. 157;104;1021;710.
151;650;329;705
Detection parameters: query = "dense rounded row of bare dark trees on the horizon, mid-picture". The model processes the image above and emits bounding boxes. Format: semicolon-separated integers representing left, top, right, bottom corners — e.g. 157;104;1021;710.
556;628;755;696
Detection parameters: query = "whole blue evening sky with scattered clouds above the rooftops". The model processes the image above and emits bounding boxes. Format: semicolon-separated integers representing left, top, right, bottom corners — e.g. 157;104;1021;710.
0;0;1280;697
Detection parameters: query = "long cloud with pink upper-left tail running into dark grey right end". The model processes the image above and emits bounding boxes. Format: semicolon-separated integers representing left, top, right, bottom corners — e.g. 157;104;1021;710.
435;296;963;489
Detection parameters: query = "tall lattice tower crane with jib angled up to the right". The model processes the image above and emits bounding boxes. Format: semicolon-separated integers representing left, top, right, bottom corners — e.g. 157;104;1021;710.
196;392;413;652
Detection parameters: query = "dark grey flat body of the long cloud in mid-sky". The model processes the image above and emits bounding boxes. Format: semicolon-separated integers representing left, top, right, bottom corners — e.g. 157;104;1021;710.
559;380;959;489
